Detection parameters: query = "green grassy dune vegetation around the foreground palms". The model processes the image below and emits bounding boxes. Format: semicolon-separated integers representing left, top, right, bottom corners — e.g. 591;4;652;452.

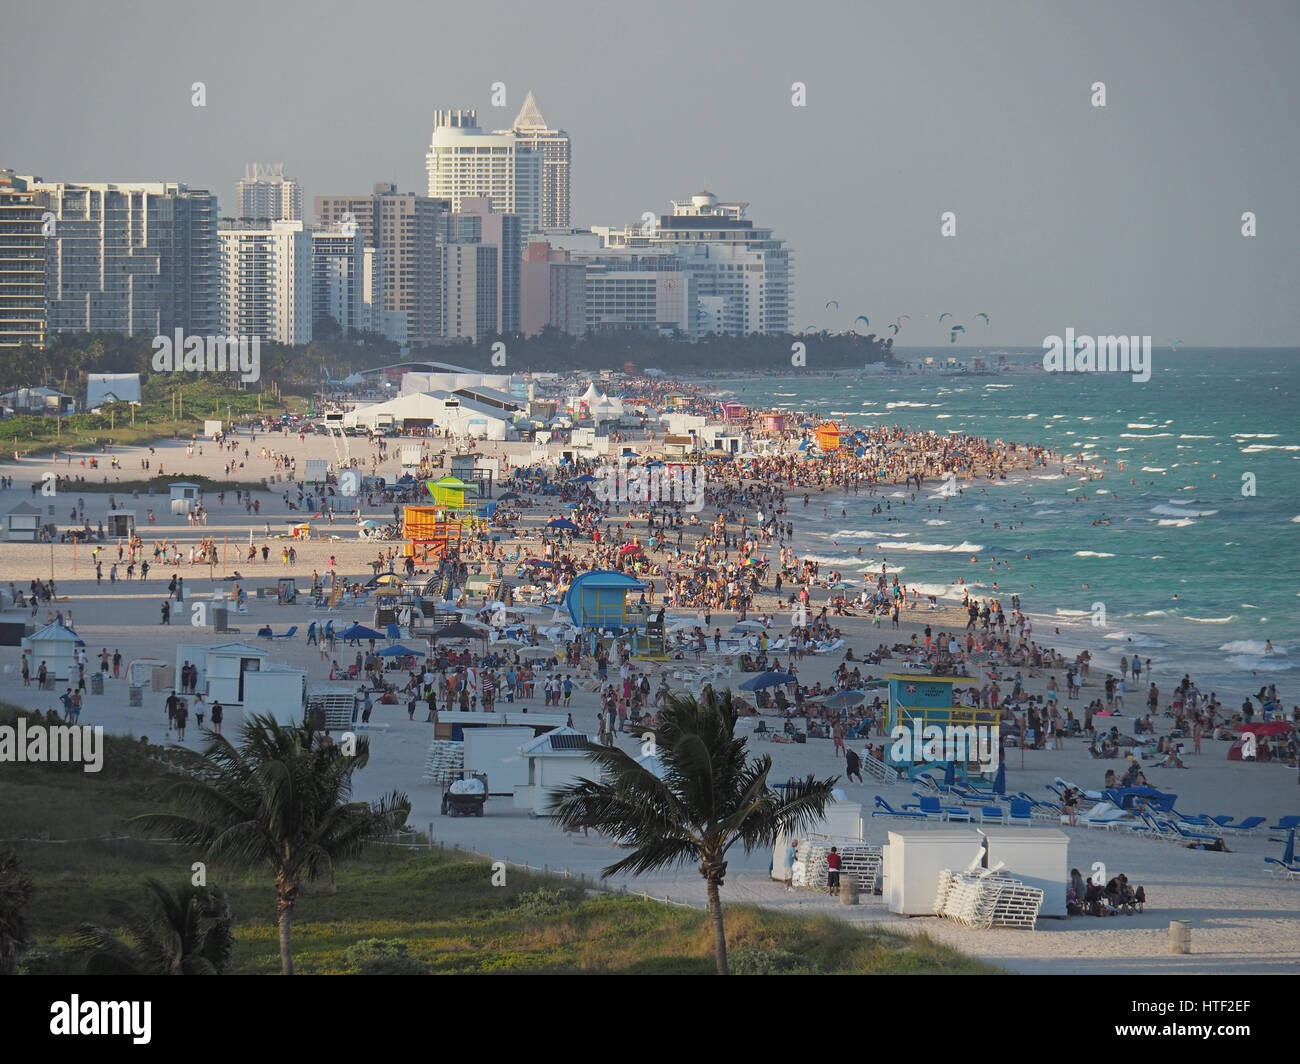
0;706;998;974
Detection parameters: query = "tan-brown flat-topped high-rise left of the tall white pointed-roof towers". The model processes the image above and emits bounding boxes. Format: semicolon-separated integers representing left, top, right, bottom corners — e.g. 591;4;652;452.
316;183;450;346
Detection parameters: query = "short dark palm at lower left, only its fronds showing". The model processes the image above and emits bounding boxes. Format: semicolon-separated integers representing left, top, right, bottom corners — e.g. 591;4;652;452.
77;879;235;976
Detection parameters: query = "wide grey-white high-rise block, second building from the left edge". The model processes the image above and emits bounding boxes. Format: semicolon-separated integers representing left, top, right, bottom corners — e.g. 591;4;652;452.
23;177;218;337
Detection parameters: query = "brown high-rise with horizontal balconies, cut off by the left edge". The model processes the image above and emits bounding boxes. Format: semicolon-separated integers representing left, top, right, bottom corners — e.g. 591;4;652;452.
0;170;52;349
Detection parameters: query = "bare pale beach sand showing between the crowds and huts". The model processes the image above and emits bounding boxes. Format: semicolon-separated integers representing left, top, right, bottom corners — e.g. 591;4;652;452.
0;432;1300;974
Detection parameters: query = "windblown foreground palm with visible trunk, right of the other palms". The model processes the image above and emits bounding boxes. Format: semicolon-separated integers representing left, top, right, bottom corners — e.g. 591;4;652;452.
551;685;837;976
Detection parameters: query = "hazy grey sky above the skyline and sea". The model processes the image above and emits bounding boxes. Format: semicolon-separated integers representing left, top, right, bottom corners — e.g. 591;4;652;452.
0;0;1300;351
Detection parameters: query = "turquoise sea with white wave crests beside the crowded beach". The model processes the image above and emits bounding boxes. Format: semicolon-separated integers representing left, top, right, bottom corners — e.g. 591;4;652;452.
711;349;1300;705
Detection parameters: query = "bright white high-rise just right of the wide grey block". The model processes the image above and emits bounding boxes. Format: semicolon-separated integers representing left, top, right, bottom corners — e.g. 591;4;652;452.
217;220;313;343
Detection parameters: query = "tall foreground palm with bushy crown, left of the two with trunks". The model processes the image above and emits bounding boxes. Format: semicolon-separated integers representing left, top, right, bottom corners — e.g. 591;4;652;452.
135;714;411;976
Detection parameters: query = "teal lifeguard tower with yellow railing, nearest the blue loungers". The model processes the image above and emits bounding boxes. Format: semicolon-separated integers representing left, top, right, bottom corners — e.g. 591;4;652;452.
884;672;1000;780
